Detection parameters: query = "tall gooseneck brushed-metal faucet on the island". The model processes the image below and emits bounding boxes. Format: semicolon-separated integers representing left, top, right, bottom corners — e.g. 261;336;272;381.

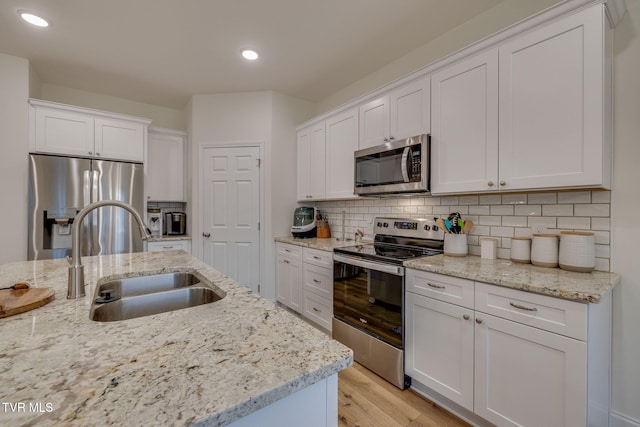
67;200;151;299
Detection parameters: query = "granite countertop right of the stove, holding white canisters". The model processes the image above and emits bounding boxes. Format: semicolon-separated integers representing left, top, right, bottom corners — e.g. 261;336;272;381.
403;255;620;303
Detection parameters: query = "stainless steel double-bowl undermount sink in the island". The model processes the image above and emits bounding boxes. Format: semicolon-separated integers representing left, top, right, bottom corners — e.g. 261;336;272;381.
90;272;224;322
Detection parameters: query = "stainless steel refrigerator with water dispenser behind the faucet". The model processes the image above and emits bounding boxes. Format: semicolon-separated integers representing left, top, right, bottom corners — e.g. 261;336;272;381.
27;154;144;260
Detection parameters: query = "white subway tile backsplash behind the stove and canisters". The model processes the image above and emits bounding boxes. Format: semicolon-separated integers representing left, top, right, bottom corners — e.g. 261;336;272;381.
316;191;611;271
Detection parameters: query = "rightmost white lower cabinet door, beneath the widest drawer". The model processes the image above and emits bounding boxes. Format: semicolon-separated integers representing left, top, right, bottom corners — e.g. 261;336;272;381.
474;312;587;426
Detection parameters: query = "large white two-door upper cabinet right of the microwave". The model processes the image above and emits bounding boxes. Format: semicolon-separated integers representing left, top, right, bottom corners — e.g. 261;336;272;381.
431;5;611;194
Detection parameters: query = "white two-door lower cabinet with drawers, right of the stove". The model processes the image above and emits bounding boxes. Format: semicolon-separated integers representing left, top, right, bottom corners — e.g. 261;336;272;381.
405;269;611;426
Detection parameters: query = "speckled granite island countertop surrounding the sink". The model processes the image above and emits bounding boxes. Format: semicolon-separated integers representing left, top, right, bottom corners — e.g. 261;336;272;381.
0;251;353;426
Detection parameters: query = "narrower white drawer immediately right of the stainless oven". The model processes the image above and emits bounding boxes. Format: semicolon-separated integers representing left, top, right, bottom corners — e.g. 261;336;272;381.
406;269;474;308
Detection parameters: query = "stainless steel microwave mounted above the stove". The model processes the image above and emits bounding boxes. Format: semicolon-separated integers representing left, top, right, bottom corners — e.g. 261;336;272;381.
354;135;431;196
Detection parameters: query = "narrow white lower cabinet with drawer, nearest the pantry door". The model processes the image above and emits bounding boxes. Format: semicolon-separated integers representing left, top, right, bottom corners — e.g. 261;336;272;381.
276;242;302;313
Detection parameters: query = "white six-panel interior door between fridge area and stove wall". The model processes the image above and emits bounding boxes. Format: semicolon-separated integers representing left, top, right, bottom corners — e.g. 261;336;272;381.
202;146;260;293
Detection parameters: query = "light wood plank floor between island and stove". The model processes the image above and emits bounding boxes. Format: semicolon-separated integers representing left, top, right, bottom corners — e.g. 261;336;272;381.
338;362;469;427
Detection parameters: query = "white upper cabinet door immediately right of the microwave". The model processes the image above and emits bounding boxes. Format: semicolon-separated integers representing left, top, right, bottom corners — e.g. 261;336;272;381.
431;50;498;194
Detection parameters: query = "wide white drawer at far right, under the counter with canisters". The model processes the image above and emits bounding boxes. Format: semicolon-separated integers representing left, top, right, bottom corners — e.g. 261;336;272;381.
475;282;588;341
